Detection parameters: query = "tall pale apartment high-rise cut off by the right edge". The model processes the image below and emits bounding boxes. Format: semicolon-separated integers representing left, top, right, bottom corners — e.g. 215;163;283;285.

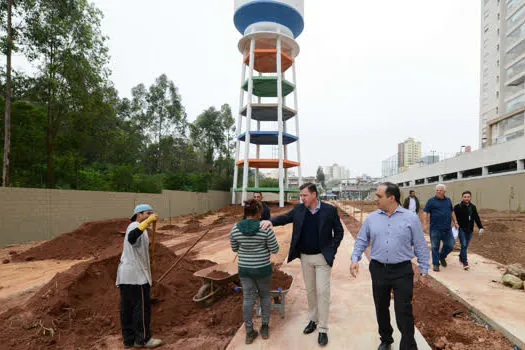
479;0;525;147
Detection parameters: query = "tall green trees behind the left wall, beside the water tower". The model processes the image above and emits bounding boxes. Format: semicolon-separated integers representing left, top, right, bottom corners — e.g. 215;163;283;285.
0;0;237;193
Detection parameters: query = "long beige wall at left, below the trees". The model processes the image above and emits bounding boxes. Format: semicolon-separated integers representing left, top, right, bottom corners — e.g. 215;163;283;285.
0;188;231;245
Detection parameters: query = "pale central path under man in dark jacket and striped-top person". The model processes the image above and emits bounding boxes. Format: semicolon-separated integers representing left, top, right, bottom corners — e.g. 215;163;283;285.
227;220;430;350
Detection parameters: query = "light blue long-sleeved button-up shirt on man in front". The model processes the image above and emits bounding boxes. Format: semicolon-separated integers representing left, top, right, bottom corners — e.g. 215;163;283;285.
352;206;430;273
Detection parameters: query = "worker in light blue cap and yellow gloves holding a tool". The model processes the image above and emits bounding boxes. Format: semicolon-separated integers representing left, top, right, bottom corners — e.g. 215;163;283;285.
117;204;162;348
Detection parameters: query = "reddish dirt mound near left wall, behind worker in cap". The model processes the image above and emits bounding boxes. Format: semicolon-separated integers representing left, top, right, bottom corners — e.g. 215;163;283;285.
13;219;130;261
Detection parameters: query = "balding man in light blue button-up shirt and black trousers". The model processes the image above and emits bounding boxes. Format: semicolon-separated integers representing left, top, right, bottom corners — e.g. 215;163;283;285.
350;182;430;350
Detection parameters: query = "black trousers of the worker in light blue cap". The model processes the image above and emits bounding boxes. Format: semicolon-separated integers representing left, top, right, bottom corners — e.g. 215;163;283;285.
119;283;151;346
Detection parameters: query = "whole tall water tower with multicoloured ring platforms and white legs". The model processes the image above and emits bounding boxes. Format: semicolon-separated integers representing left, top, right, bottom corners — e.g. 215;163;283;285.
232;0;304;207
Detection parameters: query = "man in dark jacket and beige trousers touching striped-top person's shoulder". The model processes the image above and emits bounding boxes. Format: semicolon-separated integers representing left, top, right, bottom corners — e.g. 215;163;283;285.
261;183;344;345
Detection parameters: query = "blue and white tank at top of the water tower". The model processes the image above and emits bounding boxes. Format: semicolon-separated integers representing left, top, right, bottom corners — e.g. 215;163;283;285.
233;0;304;38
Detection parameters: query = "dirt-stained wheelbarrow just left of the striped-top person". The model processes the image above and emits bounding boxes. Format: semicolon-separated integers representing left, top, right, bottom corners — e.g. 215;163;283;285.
193;262;240;306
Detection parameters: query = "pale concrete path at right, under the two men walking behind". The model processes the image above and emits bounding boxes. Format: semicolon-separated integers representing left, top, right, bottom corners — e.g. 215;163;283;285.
430;251;525;349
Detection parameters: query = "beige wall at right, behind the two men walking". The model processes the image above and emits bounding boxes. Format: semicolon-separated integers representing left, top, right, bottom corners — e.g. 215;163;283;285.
401;173;525;211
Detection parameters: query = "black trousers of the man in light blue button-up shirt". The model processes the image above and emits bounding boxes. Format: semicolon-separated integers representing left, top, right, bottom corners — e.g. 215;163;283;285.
370;260;417;350
